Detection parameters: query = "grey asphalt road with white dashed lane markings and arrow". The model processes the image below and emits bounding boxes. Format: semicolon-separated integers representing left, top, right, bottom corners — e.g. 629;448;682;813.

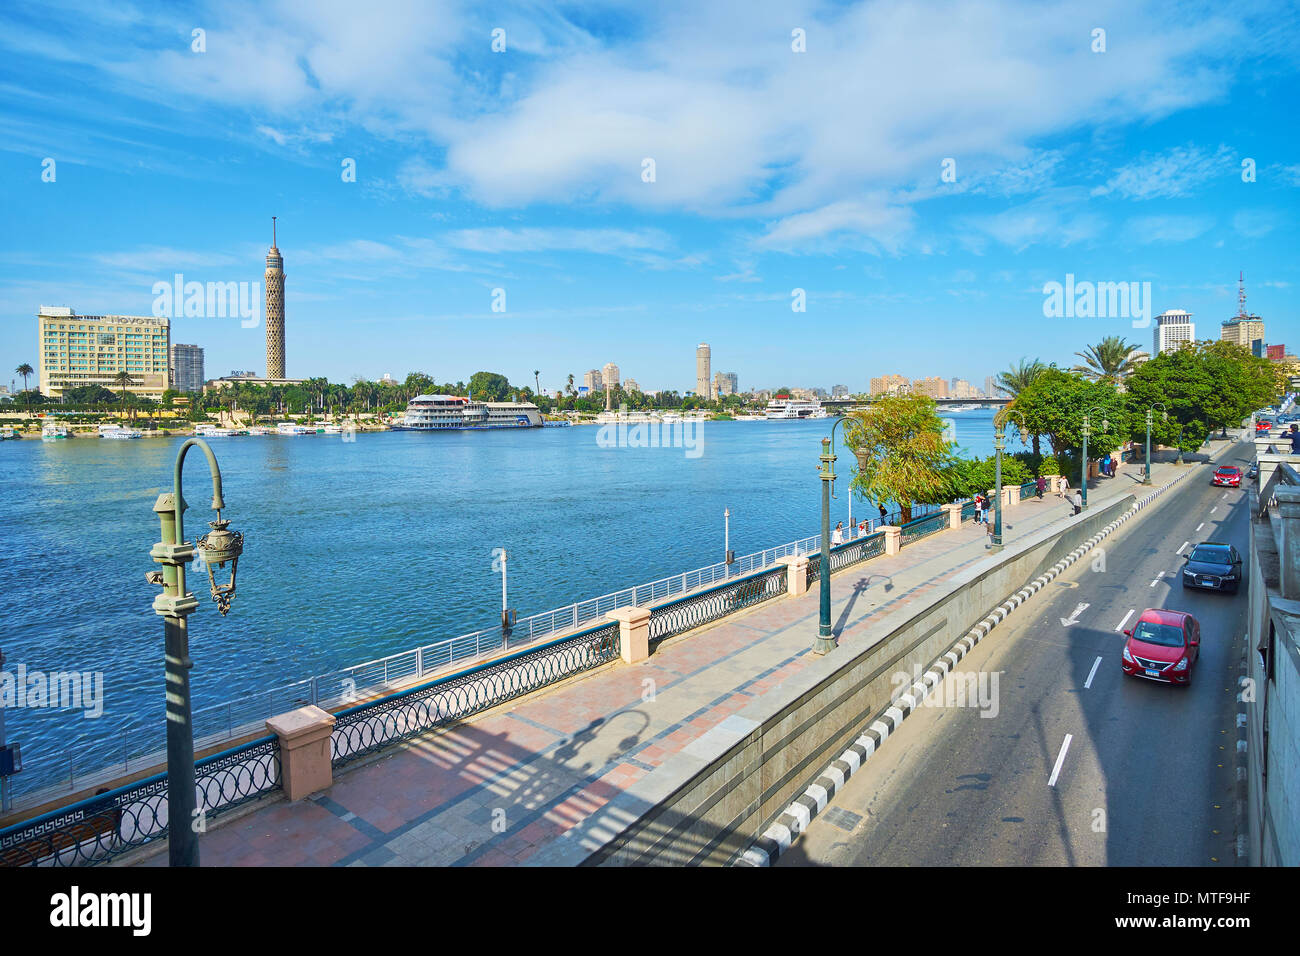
777;442;1255;866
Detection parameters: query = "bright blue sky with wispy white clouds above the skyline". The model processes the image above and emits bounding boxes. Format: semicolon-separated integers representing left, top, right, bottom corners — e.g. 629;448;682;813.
0;0;1300;392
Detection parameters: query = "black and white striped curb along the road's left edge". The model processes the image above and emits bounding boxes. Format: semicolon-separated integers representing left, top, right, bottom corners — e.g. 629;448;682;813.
732;470;1190;866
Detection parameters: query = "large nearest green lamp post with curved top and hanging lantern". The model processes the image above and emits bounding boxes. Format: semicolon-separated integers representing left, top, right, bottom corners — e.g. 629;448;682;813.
147;438;243;866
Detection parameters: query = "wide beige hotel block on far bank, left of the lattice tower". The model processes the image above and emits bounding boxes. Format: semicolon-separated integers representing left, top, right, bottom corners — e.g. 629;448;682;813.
36;306;172;398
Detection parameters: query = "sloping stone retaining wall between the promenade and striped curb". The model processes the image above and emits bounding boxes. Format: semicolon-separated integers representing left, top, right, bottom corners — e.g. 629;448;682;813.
529;496;1134;866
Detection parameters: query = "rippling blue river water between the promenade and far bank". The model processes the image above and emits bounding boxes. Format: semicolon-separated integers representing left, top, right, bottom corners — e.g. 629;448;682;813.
0;408;992;792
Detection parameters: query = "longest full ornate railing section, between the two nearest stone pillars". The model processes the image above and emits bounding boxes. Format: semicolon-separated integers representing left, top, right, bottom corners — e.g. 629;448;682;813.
330;622;619;766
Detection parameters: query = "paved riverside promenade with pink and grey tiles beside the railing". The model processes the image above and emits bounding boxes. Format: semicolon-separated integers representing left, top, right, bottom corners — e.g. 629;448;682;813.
131;455;1206;866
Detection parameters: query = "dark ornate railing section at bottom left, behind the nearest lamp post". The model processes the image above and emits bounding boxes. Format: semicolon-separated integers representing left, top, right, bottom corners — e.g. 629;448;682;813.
0;736;282;866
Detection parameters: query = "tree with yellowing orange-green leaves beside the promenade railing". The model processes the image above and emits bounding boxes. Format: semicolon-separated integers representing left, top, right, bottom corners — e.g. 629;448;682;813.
844;395;950;522
